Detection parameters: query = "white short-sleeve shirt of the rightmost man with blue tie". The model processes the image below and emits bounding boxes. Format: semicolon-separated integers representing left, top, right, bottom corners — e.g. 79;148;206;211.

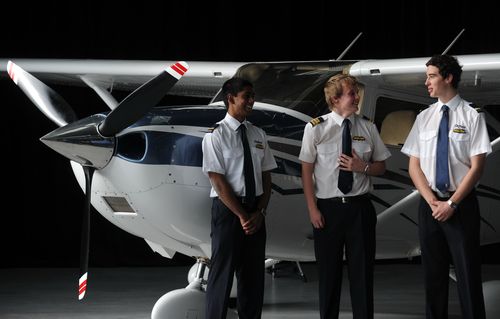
401;95;491;191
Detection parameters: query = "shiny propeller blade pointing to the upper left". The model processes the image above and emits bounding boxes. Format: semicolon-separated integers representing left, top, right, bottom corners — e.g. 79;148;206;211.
7;61;78;126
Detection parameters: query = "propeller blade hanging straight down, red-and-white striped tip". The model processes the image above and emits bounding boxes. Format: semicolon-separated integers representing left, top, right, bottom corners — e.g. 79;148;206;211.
78;166;95;300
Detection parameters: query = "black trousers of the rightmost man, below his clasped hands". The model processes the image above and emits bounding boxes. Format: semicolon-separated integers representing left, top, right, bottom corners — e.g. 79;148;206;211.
419;191;485;319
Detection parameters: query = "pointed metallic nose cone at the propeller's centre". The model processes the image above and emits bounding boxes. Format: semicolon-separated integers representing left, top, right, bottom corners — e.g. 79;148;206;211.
40;114;115;169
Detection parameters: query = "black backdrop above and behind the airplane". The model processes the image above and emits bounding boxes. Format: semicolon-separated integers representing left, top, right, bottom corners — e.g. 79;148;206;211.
0;0;500;267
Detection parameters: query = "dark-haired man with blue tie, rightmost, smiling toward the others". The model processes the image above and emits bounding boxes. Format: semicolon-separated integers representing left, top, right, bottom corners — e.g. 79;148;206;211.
401;55;491;319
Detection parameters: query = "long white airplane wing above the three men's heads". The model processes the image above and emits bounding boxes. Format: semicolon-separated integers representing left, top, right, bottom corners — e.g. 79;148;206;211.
4;54;500;109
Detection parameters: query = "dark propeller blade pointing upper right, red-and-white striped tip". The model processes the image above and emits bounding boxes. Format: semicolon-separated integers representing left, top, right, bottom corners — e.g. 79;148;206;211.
99;61;188;137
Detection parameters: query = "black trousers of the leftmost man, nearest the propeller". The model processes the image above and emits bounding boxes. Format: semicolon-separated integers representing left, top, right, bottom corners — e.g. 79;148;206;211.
206;198;266;319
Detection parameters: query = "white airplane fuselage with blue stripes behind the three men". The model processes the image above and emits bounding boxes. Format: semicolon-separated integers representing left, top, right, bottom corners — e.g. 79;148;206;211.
68;103;500;261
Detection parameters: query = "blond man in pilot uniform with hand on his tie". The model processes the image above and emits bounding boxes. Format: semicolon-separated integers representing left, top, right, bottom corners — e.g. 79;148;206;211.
299;74;391;319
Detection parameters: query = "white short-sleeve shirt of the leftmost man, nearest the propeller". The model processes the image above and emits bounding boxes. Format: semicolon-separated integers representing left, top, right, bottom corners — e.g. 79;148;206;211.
202;113;277;197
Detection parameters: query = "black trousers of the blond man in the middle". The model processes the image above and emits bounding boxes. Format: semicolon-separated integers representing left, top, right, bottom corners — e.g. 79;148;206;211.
313;196;377;319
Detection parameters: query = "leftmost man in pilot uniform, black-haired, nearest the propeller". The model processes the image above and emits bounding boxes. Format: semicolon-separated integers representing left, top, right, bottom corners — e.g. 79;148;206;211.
202;78;277;319
